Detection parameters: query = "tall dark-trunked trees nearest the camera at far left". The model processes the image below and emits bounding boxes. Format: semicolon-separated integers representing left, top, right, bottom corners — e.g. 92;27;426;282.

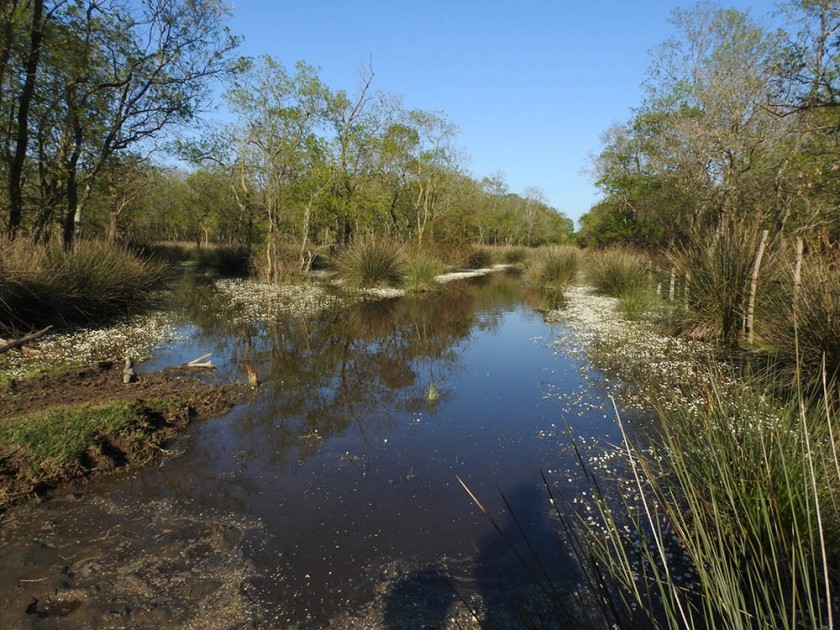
0;0;236;245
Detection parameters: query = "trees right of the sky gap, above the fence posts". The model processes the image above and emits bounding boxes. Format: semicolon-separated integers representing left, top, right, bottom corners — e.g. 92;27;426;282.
579;0;840;248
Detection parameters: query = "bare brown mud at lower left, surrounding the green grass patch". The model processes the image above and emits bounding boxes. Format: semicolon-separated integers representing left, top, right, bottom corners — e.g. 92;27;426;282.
0;363;260;629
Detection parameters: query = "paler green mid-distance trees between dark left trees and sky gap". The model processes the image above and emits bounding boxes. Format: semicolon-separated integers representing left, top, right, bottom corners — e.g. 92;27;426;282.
176;57;574;275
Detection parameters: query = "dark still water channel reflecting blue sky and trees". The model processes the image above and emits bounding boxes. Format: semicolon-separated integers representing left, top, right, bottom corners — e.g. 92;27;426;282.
0;274;632;628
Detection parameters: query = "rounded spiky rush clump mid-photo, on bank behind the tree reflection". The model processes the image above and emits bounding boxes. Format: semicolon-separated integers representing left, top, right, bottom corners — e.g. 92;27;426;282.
337;240;406;288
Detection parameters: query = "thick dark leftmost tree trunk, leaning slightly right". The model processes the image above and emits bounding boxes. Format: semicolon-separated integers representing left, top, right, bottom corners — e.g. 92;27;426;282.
8;0;44;238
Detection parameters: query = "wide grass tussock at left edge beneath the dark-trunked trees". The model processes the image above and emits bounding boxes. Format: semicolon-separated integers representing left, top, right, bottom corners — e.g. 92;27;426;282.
0;239;166;329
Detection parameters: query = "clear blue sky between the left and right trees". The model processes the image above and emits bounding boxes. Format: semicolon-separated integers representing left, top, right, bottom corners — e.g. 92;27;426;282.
225;0;774;225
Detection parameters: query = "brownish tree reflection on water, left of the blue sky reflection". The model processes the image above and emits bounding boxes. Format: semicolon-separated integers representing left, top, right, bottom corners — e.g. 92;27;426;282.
226;276;521;460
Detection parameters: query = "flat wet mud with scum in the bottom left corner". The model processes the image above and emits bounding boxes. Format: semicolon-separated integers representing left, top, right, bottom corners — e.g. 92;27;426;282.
0;494;261;630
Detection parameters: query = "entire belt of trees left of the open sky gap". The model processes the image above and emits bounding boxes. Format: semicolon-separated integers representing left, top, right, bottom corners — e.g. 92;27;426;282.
0;0;573;266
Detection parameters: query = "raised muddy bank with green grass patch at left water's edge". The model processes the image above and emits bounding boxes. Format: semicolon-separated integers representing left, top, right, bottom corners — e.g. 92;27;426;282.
0;362;249;512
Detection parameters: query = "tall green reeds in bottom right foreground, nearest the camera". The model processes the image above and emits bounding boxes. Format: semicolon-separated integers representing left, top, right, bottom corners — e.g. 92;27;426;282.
588;374;840;629
